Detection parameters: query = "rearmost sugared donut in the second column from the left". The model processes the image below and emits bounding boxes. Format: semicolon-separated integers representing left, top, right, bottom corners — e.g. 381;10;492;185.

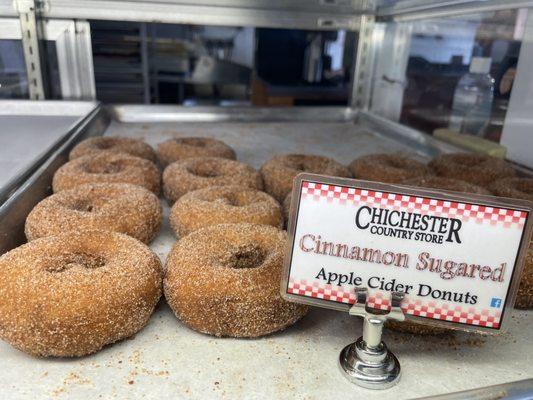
157;137;236;166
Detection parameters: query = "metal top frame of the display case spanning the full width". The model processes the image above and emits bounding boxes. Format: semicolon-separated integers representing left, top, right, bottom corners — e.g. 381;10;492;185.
4;0;533;30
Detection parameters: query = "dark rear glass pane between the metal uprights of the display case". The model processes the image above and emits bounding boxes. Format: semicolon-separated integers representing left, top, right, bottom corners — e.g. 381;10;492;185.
91;21;355;106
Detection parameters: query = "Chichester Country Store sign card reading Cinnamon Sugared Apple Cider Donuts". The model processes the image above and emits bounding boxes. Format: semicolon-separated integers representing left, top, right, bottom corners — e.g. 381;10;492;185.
282;174;531;331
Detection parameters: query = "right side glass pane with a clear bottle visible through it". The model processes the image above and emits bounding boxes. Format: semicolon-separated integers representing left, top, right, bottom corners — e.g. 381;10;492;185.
401;10;524;142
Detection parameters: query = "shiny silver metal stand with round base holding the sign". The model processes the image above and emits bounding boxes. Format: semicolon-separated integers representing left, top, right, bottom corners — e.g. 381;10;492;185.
339;288;405;389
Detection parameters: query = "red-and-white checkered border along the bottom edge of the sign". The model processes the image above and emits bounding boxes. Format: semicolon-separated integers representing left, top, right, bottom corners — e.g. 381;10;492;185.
287;278;502;329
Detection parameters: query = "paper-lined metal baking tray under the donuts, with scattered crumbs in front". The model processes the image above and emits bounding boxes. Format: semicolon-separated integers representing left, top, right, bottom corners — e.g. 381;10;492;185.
0;106;533;399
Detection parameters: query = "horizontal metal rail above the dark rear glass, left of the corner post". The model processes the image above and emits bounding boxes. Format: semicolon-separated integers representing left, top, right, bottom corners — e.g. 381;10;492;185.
4;0;362;30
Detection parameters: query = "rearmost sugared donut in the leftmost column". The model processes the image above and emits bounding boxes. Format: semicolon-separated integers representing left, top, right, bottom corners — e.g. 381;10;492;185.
69;136;155;162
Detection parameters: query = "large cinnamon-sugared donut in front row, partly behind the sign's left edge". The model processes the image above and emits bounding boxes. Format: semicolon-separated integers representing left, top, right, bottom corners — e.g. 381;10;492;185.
164;224;307;337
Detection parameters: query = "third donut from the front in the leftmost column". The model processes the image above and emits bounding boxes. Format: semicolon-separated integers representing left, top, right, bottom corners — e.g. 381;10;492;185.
52;151;161;194
